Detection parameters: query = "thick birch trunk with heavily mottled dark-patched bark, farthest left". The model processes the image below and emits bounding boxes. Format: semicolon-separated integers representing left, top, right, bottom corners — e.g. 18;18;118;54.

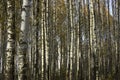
4;0;15;80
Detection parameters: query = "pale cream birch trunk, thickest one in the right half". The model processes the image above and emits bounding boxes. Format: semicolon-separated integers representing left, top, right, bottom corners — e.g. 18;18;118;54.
89;0;98;80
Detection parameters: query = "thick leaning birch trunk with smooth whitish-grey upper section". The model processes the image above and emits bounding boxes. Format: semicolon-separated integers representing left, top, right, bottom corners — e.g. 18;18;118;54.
18;0;30;80
